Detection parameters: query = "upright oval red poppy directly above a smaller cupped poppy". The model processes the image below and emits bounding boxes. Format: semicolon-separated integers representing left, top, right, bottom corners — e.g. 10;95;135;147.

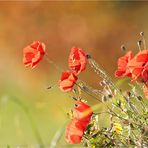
68;47;87;74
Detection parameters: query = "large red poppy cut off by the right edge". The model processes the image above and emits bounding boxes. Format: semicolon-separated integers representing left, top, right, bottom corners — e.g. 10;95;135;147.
127;50;148;83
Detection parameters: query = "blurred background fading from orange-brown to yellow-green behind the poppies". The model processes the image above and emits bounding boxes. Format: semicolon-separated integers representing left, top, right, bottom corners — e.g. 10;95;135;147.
0;1;148;147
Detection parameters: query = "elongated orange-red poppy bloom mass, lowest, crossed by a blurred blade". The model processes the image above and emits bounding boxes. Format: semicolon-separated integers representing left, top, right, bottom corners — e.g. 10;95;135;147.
65;101;93;144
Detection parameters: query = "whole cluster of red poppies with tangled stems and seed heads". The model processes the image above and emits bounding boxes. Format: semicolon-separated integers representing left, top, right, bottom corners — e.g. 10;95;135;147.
23;33;148;148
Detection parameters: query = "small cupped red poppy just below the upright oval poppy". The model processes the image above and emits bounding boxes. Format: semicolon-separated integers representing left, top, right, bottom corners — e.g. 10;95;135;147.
59;71;78;92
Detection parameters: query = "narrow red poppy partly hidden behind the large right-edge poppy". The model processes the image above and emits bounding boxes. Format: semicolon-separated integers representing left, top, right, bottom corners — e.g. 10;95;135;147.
115;51;133;77
